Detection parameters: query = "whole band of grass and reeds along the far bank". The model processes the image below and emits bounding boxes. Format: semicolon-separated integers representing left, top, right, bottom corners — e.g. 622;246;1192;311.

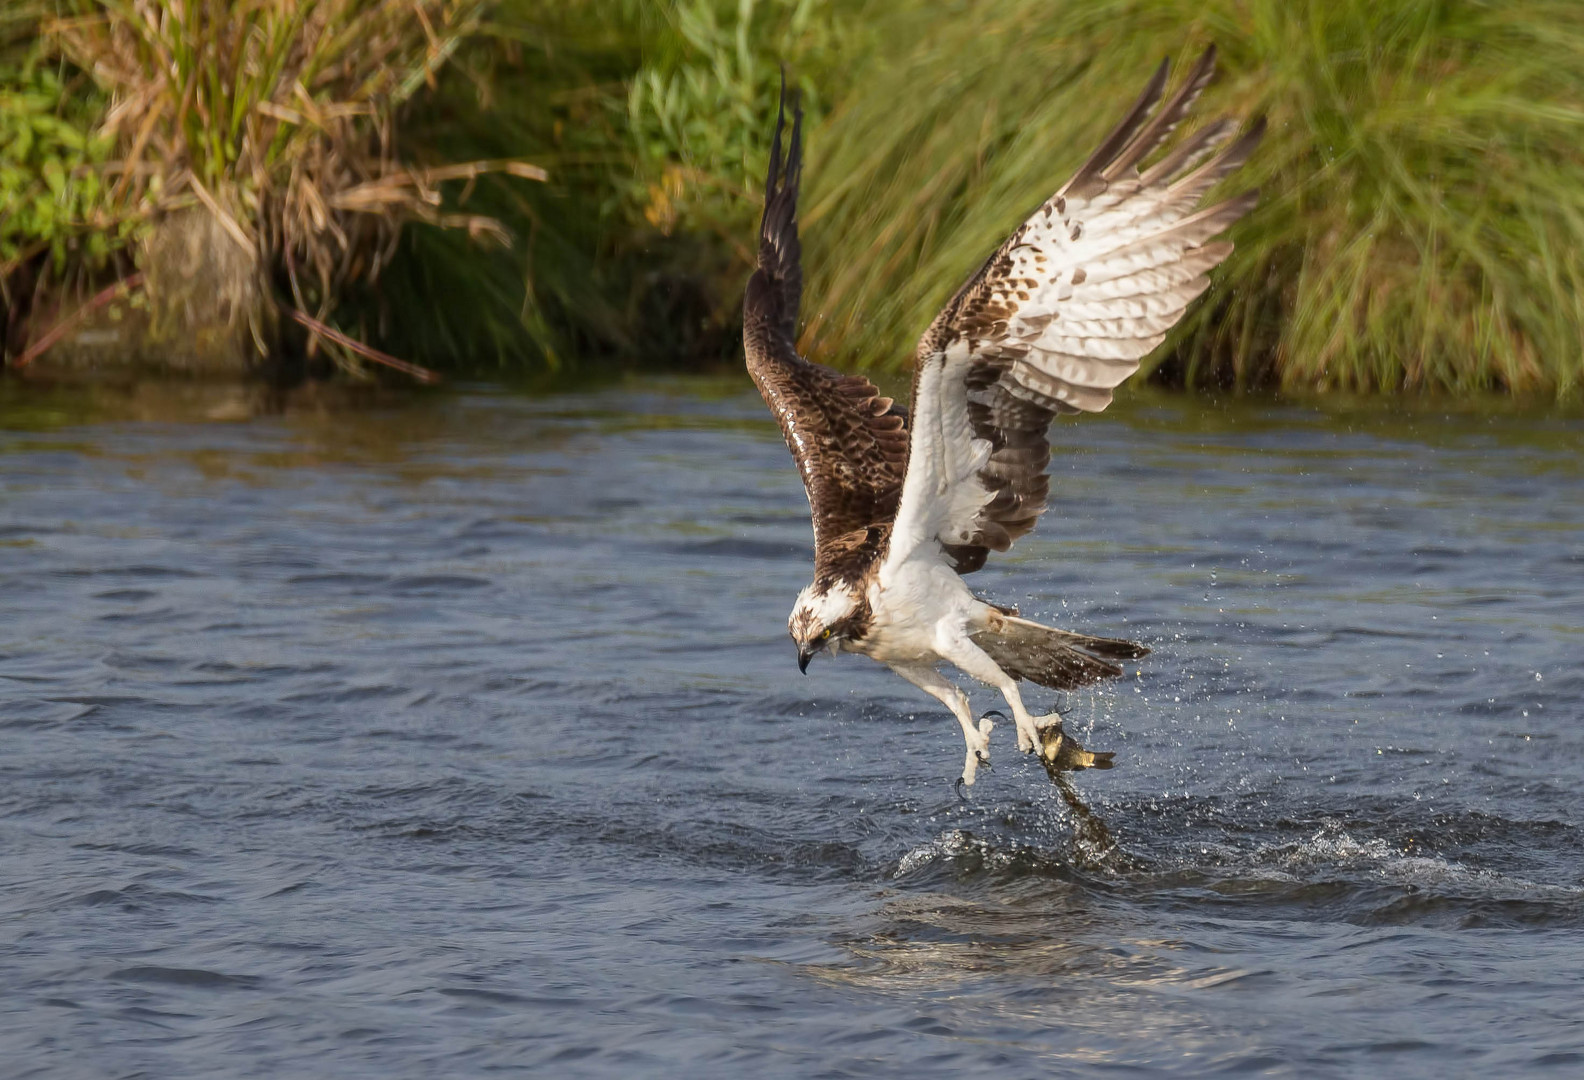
0;0;1584;396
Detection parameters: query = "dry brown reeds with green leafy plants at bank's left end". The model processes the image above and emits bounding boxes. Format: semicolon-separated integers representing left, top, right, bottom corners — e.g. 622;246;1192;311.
0;0;543;371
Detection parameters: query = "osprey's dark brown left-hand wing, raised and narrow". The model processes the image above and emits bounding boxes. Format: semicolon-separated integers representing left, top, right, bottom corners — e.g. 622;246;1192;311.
743;87;908;580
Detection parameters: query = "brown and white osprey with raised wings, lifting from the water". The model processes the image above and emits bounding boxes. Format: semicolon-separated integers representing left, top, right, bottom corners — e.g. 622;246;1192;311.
743;48;1264;785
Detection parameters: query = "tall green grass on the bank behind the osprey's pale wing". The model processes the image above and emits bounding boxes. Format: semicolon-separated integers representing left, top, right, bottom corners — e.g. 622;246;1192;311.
803;0;1584;394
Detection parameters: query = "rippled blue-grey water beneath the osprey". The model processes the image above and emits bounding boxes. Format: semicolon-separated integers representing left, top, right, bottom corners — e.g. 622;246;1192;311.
0;372;1584;1078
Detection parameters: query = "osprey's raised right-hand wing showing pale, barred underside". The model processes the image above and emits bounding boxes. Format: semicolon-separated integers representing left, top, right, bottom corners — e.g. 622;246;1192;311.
887;48;1264;573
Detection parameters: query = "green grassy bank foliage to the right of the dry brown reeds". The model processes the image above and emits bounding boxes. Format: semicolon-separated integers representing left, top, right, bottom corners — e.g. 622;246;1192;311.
0;0;1584;396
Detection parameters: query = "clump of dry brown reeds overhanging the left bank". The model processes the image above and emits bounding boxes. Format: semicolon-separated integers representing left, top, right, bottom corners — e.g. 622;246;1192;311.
10;0;543;367
